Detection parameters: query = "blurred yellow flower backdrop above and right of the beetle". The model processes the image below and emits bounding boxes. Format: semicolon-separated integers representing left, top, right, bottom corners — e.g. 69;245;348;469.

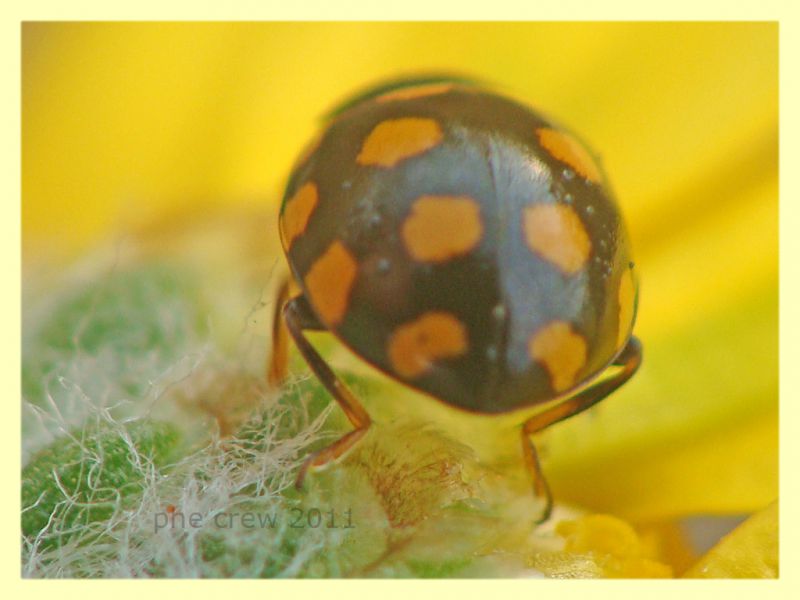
22;23;778;519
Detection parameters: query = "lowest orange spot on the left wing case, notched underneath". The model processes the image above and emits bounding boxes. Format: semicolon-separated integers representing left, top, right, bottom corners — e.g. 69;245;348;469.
387;311;467;379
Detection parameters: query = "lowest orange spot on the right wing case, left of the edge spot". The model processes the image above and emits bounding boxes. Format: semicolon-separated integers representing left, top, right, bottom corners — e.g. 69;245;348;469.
528;321;586;392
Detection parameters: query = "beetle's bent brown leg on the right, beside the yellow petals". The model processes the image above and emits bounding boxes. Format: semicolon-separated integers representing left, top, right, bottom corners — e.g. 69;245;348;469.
522;337;642;524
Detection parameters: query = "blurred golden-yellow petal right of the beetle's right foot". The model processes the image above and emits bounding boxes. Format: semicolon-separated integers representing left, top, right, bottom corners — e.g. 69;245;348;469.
550;414;778;521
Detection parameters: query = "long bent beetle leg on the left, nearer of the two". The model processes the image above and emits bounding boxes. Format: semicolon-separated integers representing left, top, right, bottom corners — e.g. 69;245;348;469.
283;296;372;488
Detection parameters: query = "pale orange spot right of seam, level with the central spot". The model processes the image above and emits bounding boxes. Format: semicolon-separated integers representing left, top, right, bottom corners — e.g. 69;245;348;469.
522;204;592;275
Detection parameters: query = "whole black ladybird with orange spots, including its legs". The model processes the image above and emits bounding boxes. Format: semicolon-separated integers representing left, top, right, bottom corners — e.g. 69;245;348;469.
268;78;642;522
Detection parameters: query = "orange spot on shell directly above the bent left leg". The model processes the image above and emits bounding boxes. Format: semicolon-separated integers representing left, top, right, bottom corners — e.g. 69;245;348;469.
305;241;358;327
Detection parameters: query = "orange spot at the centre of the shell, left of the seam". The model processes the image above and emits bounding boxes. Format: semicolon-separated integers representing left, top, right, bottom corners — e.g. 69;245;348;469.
402;196;483;262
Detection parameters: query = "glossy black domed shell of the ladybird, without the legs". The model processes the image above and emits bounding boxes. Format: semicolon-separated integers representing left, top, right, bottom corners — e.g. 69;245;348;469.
281;82;637;413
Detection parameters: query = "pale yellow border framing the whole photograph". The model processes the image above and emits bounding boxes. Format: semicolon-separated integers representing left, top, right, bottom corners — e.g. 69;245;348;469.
0;0;800;600
